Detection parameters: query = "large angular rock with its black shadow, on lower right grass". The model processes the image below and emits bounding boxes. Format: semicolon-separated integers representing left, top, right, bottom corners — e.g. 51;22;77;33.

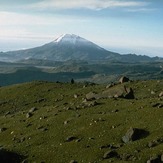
122;127;149;143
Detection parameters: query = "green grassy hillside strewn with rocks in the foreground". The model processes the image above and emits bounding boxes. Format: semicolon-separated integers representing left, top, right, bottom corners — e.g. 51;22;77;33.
0;80;163;163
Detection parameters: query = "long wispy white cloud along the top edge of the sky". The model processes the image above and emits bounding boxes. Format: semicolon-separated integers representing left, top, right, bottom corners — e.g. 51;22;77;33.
32;0;148;10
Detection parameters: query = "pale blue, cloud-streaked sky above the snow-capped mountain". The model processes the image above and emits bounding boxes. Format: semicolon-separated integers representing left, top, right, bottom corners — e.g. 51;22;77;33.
0;0;163;57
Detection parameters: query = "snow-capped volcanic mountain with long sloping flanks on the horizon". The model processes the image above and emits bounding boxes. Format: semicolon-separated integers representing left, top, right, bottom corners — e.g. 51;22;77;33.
0;34;159;62
